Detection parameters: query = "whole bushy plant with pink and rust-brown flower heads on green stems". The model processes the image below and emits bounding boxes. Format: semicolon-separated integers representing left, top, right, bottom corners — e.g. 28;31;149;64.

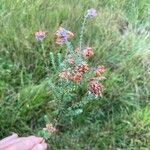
35;8;105;131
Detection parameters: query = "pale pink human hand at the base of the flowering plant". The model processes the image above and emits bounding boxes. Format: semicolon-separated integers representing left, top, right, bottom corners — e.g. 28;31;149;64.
0;134;47;150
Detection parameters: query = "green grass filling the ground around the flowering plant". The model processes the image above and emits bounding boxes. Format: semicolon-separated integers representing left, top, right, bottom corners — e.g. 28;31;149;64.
0;0;150;150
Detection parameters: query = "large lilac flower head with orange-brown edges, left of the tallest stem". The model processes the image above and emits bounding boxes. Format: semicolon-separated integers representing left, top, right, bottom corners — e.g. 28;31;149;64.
55;27;74;45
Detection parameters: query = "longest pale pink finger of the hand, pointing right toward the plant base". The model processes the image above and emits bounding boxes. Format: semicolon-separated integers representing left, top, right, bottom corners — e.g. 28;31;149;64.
0;136;43;150
